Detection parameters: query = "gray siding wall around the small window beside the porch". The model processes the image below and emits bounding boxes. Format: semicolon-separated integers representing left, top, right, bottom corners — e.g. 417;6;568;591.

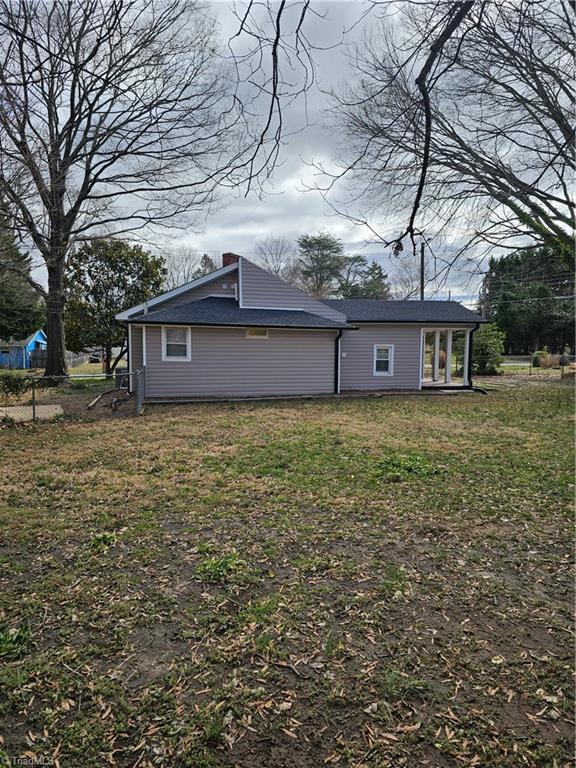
340;323;421;390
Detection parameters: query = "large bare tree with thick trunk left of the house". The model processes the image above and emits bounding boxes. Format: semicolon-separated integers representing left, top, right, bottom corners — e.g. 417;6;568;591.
0;0;247;374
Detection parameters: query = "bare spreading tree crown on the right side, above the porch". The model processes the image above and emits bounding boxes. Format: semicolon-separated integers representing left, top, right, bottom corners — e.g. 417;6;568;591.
332;0;575;258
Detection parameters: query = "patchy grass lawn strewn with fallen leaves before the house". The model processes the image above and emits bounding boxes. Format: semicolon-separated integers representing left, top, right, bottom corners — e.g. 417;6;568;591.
0;377;574;768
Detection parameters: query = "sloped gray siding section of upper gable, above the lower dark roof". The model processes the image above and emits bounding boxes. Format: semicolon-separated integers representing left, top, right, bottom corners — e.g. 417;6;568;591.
241;259;346;323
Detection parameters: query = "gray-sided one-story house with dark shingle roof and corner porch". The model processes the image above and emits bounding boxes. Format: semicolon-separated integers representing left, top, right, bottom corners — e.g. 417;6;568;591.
116;253;483;400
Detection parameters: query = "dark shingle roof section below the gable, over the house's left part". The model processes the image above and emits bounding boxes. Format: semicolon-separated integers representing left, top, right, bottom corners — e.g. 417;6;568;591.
130;297;350;328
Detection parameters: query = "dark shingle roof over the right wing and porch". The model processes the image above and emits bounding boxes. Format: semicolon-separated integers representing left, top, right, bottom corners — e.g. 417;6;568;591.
324;299;485;323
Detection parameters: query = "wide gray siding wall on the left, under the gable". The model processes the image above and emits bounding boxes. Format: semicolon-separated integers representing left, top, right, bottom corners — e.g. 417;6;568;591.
146;326;336;398
